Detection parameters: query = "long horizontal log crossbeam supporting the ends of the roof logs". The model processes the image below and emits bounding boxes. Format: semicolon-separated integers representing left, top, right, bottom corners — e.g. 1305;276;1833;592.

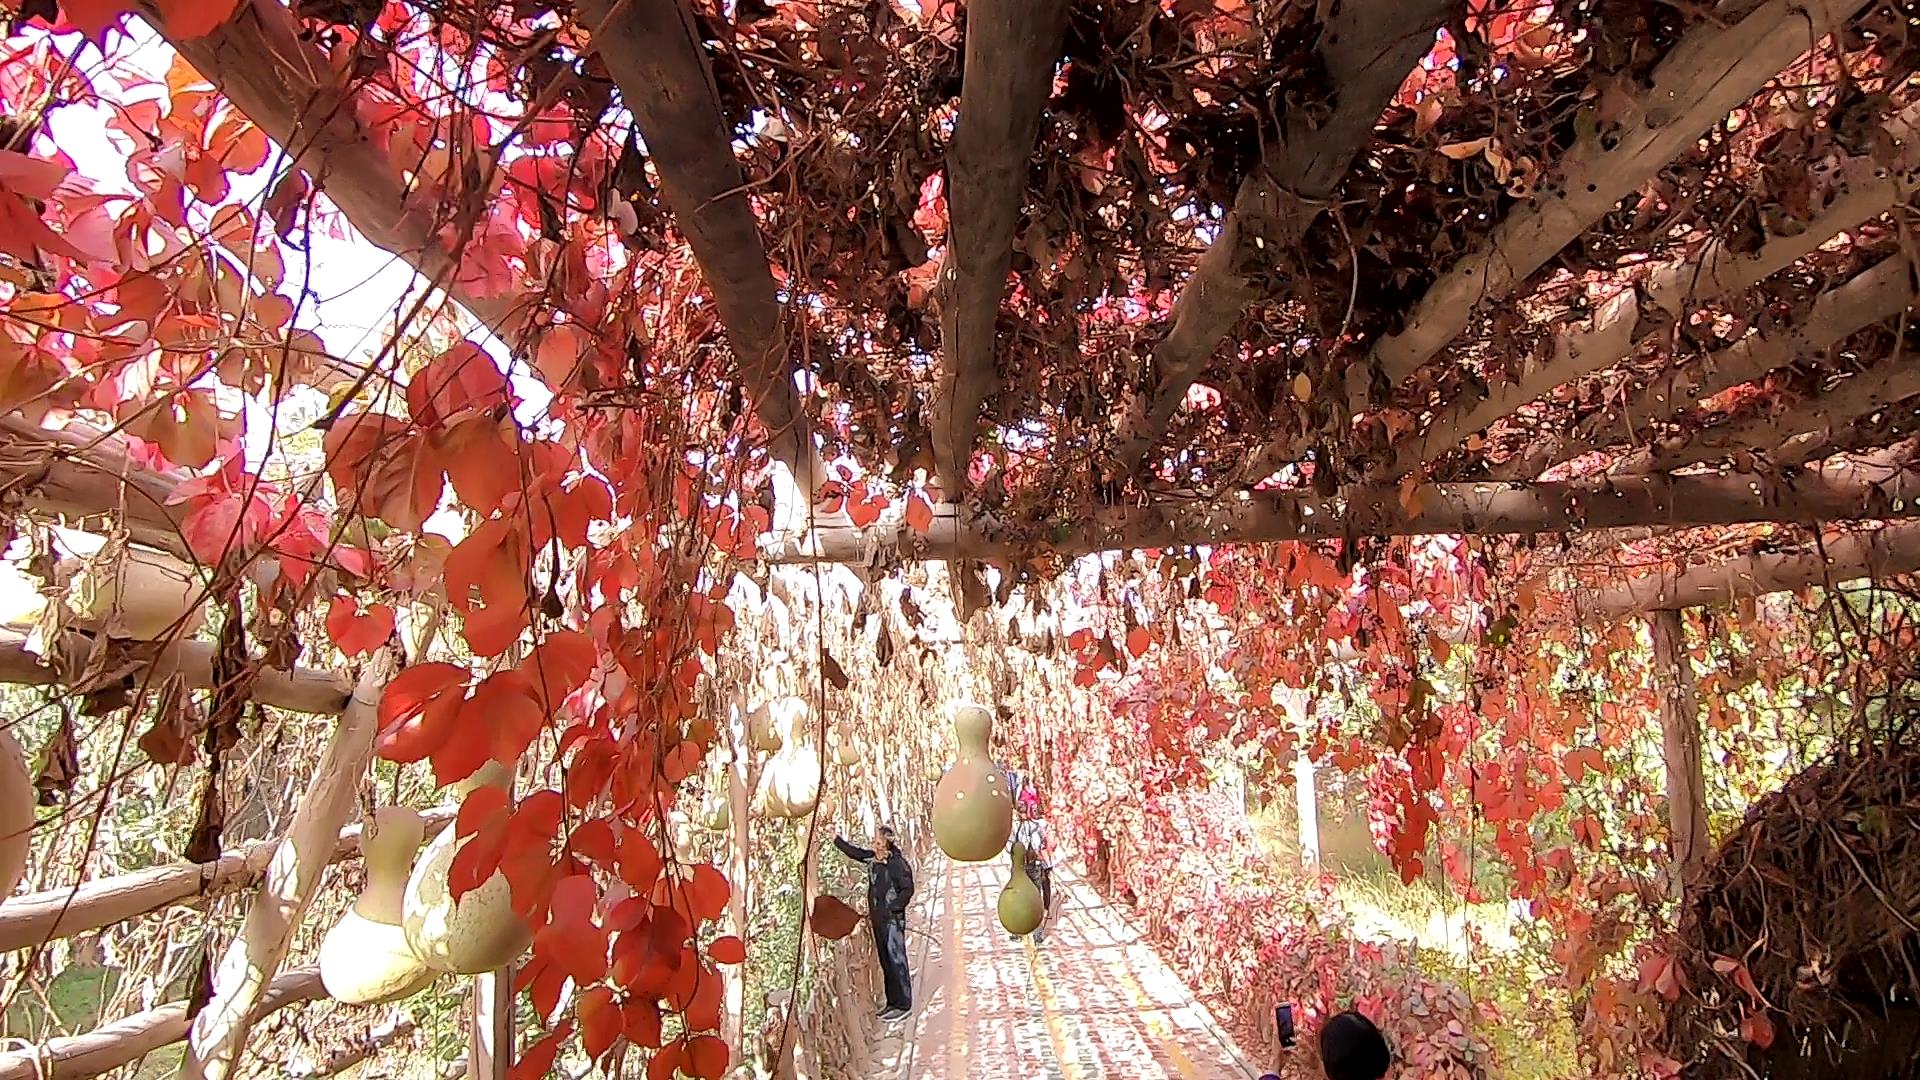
762;447;1920;563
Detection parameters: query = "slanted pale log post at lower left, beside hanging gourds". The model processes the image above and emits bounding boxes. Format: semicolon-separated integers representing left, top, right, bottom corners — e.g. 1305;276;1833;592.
180;650;394;1080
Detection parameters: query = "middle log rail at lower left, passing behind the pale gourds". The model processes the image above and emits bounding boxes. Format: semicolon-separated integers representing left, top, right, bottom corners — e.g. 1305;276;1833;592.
0;807;453;951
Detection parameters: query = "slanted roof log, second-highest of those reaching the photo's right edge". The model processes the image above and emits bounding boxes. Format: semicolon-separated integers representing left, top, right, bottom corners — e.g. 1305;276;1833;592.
1488;254;1920;480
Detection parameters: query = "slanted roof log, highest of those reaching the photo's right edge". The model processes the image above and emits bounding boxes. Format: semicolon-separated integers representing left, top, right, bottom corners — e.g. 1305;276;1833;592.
1375;106;1920;480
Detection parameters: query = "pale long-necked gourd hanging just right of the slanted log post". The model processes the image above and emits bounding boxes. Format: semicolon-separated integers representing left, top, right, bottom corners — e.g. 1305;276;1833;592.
321;807;435;1005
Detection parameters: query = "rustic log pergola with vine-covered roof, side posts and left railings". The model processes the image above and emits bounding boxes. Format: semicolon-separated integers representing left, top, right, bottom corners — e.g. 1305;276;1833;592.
0;0;1920;1076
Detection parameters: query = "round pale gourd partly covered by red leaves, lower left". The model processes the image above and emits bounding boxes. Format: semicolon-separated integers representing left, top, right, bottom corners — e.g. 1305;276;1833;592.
401;761;534;974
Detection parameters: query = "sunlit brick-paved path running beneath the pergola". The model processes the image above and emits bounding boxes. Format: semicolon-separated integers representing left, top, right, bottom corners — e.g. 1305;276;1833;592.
867;859;1256;1080
